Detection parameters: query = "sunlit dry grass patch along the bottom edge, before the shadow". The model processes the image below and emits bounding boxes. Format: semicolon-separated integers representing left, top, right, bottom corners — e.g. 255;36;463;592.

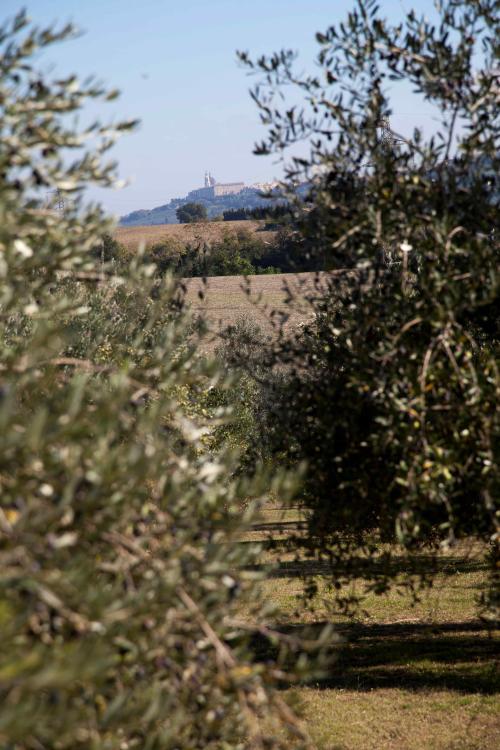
300;686;500;750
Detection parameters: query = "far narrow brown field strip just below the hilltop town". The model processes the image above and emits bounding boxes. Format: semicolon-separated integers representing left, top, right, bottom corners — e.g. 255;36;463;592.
114;221;276;250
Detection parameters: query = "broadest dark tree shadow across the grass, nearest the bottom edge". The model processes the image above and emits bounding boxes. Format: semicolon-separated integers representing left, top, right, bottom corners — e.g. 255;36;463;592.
254;621;500;694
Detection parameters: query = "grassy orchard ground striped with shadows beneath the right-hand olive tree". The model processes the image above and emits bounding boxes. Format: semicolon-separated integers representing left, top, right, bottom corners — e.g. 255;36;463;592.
246;508;500;750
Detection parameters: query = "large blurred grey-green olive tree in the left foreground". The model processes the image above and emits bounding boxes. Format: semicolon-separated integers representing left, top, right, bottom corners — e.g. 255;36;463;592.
0;14;328;750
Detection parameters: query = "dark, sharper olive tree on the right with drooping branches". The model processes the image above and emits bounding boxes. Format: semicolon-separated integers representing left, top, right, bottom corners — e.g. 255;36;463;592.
240;0;500;612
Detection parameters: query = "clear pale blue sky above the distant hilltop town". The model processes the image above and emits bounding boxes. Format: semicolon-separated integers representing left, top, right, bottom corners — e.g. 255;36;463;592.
0;0;438;214
